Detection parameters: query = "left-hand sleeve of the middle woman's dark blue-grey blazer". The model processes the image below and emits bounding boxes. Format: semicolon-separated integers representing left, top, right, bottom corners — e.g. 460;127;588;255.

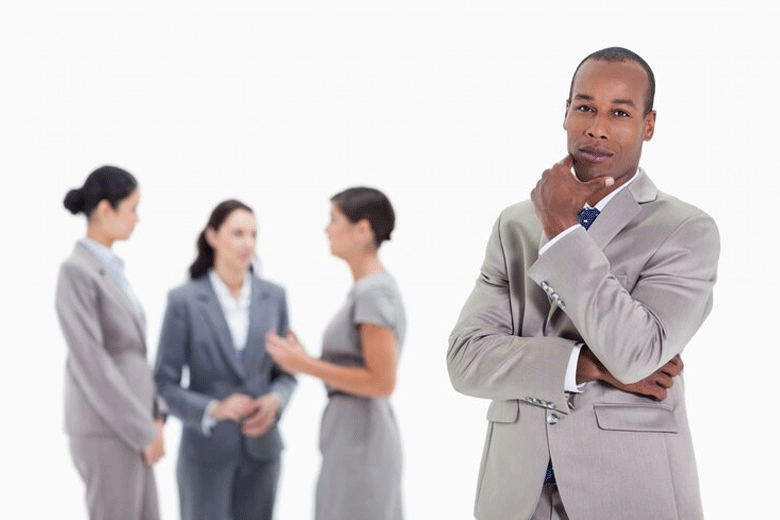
154;292;213;431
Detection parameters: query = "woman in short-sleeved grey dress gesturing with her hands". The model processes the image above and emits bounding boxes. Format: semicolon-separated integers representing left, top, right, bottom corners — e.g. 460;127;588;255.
266;187;406;520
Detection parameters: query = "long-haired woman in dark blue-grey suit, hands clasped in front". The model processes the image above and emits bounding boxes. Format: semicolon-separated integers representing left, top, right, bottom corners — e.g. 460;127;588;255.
155;200;296;520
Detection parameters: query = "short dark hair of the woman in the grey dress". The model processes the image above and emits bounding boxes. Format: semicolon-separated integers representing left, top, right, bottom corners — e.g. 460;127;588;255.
330;186;395;248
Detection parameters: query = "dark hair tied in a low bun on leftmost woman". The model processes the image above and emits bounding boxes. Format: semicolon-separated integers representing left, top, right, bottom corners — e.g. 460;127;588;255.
62;166;138;218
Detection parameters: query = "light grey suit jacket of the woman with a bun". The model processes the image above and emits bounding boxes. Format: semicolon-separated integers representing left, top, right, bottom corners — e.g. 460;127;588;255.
55;244;158;452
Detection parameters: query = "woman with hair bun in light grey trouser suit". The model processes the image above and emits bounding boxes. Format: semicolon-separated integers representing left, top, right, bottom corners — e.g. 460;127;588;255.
56;166;164;520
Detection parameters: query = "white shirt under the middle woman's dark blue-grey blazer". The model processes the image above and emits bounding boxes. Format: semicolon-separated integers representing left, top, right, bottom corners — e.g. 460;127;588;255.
201;269;252;435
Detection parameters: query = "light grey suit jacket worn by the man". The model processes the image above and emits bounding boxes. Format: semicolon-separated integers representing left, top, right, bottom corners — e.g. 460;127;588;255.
447;171;720;520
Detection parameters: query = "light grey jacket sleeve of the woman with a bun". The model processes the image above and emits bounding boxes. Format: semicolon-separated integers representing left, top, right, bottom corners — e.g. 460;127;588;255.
56;264;157;452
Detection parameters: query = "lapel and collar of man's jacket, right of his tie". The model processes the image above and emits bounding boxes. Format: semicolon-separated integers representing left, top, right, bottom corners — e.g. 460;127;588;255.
539;168;658;253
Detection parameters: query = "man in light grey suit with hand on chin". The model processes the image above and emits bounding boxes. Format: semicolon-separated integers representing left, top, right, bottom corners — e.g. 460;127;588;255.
447;47;719;520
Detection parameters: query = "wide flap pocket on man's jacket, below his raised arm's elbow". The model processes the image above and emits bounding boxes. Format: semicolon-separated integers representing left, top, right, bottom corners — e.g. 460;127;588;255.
593;404;679;433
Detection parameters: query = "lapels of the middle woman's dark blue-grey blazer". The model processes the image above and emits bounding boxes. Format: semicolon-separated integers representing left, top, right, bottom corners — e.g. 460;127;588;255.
193;275;269;379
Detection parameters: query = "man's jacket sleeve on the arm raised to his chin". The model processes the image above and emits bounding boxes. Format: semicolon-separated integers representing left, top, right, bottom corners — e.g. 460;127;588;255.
528;212;720;383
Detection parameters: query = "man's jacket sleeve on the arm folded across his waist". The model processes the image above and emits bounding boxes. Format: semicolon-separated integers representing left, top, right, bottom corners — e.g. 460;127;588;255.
447;209;575;413
